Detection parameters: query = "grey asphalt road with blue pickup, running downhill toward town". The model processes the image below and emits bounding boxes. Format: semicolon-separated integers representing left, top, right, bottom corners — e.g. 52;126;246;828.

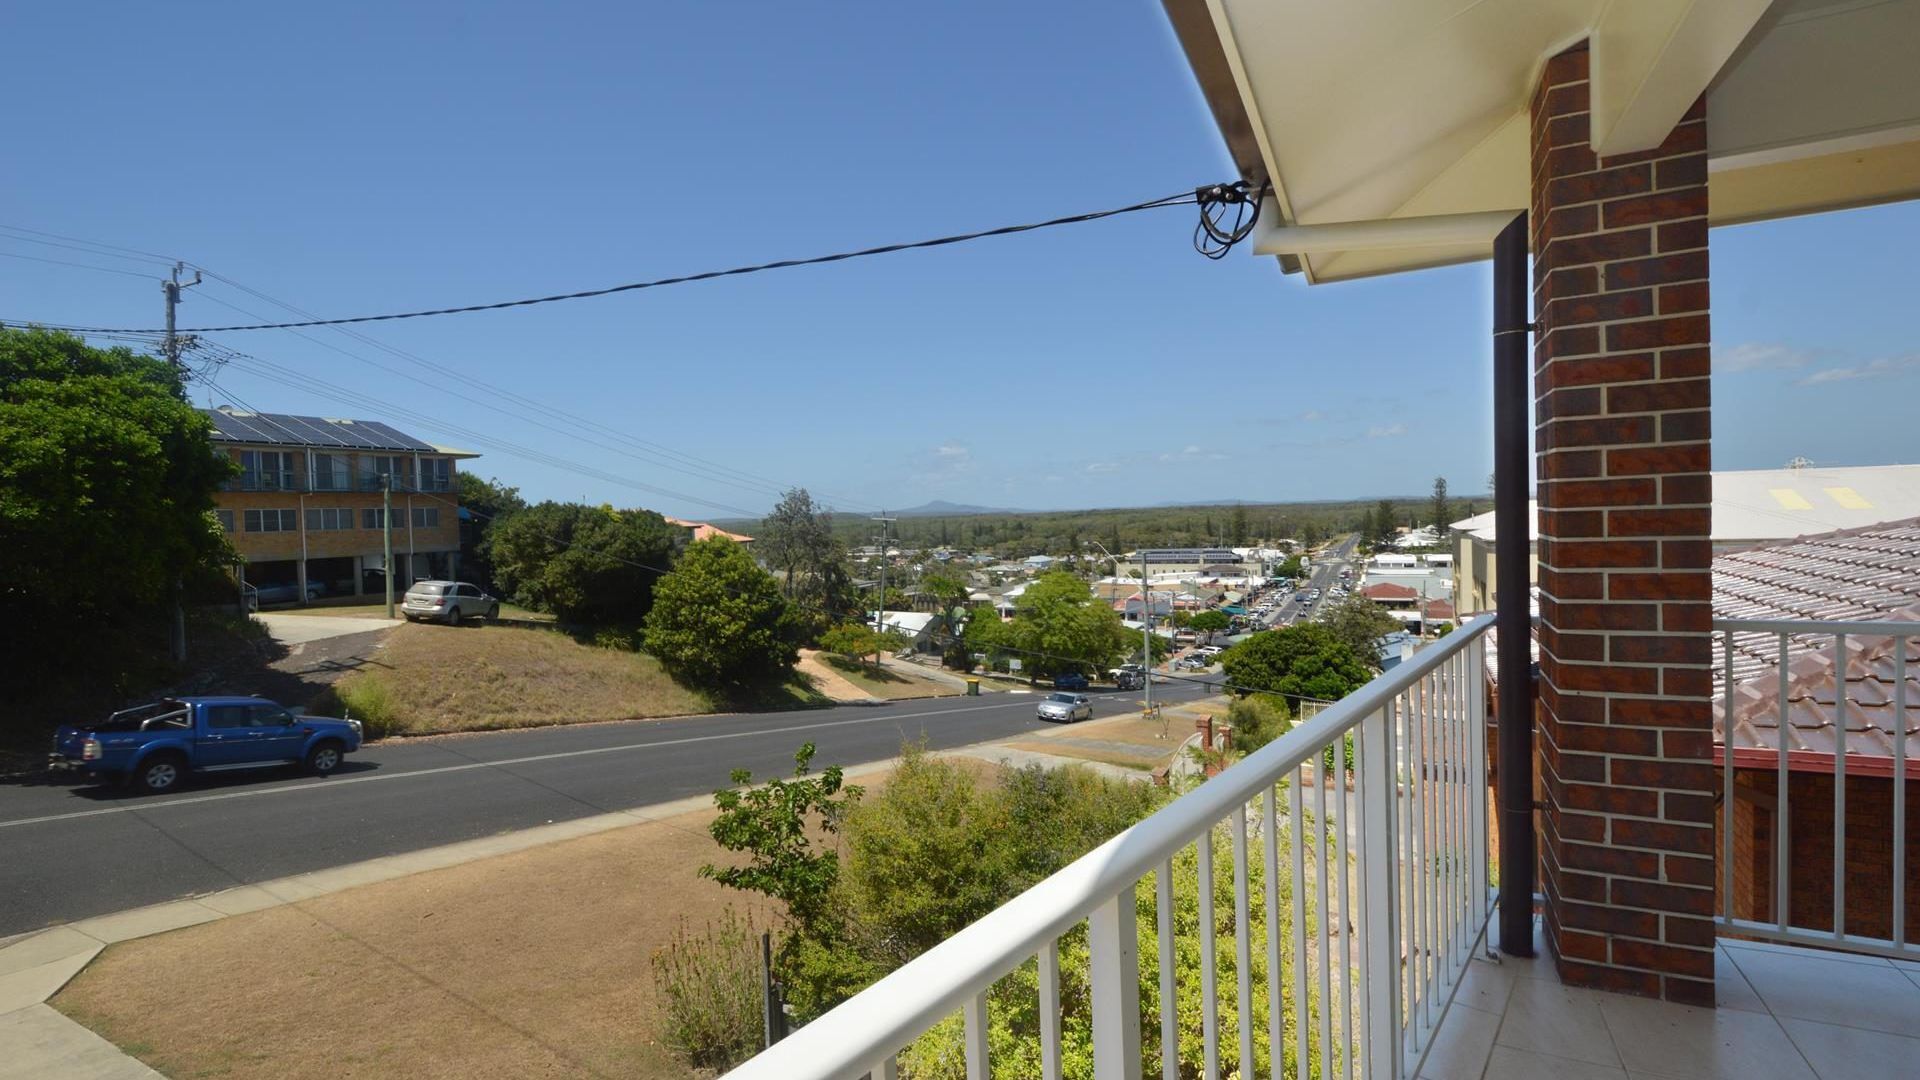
0;682;1204;936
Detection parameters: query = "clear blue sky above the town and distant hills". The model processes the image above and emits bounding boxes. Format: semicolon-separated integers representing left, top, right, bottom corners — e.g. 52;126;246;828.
0;0;1920;517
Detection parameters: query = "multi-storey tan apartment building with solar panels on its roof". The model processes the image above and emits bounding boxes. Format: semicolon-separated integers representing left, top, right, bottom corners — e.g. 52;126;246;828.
202;405;476;598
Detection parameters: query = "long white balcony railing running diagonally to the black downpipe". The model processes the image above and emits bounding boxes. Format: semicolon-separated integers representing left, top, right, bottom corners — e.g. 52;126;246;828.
732;617;1492;1080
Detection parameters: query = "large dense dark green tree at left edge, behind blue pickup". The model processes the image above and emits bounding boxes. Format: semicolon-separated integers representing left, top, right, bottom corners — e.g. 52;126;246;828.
0;329;238;717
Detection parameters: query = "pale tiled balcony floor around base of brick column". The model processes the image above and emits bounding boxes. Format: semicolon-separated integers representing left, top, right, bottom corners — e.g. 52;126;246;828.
1421;914;1920;1080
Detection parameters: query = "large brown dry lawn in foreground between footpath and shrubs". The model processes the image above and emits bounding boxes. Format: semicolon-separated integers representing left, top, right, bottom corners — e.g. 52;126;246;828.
54;811;766;1080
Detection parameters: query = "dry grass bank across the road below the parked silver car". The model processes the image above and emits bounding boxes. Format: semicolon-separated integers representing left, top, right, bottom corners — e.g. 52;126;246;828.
338;625;714;734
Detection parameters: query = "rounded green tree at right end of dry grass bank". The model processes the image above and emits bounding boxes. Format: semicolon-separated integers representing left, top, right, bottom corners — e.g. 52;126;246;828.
645;536;799;692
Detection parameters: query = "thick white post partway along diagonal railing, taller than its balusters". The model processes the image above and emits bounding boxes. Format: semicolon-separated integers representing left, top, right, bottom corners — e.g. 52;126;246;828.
1359;709;1400;1080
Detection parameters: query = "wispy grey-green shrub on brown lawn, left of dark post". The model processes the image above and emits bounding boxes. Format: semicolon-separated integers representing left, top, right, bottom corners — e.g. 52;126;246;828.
653;907;764;1070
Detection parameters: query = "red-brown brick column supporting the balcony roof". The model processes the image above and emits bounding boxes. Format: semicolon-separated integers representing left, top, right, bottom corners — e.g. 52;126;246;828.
1532;46;1715;1005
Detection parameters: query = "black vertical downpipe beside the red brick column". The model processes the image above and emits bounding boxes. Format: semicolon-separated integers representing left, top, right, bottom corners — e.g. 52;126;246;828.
1494;211;1534;957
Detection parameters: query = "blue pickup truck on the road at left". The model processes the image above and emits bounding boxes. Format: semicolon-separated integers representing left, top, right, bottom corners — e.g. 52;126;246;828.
48;698;361;794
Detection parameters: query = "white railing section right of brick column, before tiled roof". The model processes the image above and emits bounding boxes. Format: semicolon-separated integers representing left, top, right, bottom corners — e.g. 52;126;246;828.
1713;619;1920;959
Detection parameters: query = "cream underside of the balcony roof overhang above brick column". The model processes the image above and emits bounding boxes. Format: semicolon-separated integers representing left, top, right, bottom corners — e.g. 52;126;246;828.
1162;0;1920;282
